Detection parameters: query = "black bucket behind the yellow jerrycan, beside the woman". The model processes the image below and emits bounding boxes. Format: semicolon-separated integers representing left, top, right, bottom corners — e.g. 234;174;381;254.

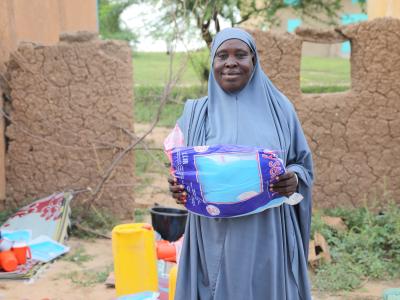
150;206;188;242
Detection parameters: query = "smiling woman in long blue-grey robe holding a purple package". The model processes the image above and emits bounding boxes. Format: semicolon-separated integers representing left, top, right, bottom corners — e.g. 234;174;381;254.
169;28;313;300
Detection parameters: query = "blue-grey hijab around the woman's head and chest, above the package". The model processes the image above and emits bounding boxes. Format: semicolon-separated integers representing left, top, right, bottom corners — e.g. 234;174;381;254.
181;28;291;152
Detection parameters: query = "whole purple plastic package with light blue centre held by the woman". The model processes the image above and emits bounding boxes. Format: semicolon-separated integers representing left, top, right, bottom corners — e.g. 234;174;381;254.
168;145;287;218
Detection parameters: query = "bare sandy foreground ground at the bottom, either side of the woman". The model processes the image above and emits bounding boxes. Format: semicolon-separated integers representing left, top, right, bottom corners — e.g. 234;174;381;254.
0;238;400;300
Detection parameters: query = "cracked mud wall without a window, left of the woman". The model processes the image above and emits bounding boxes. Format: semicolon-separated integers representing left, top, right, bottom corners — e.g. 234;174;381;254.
6;33;134;216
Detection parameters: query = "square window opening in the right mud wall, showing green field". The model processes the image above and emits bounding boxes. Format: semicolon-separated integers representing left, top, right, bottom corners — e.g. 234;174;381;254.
300;42;351;93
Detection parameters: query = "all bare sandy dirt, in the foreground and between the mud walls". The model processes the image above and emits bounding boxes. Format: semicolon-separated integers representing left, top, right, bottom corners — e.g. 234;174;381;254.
0;125;400;300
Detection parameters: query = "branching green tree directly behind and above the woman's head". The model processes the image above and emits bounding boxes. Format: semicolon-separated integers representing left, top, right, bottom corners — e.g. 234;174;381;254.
156;0;342;48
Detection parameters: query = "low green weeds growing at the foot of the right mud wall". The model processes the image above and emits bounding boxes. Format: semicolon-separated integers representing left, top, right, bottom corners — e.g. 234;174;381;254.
312;203;400;291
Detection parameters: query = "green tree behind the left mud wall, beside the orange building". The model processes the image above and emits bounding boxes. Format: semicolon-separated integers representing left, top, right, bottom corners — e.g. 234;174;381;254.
99;0;138;44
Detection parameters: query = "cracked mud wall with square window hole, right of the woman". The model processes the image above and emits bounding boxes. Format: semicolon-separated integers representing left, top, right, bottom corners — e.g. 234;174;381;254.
254;18;400;208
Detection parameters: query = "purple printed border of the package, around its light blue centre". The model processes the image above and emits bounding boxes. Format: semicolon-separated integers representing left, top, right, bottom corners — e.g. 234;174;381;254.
170;145;285;218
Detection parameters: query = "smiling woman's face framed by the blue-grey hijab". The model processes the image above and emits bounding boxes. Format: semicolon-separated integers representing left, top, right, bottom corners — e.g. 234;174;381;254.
213;39;254;93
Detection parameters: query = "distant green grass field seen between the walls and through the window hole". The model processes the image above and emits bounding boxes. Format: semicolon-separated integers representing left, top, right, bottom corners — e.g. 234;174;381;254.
133;50;350;127
